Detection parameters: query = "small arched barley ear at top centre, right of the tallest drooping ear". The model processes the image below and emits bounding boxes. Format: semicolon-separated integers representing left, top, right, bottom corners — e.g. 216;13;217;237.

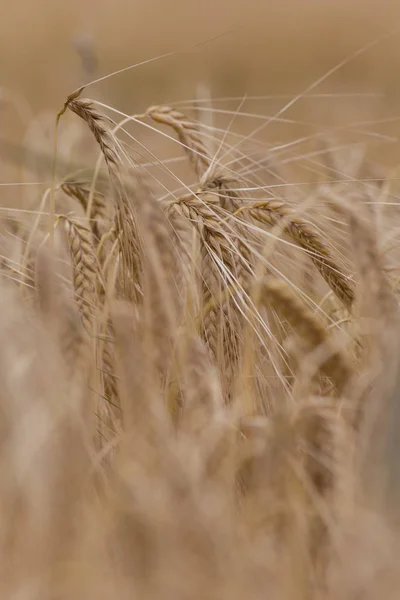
146;106;211;179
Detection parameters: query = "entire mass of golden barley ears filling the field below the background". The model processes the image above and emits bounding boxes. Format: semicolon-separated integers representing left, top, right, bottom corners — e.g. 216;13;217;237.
0;76;400;600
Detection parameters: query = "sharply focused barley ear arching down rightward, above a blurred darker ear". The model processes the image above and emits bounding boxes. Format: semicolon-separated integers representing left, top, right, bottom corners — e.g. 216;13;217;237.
244;200;354;309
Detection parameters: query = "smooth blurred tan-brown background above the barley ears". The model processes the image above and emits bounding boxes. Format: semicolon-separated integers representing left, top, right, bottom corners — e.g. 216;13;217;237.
0;0;400;185
